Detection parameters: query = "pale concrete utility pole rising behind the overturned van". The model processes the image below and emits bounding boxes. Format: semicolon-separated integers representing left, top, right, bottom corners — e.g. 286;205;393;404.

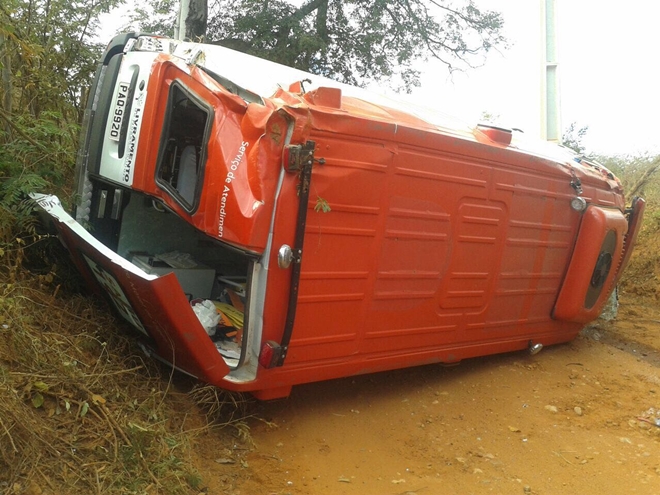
540;0;561;142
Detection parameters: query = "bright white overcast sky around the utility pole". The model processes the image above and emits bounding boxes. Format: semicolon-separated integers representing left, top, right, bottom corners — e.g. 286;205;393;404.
99;0;660;155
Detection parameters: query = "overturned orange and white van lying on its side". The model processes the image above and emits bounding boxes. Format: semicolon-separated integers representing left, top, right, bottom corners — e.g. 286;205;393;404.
34;34;644;399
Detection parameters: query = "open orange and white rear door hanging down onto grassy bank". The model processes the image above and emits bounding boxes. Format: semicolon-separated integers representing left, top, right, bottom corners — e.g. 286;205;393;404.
32;194;229;383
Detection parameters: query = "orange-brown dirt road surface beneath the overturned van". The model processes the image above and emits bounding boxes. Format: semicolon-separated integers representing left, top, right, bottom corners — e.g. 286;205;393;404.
199;298;660;495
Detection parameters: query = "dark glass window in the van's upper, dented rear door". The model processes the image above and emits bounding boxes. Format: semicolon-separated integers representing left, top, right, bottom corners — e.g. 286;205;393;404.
156;82;212;211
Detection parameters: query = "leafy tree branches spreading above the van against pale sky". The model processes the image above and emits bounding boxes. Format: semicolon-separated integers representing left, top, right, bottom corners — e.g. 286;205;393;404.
134;0;506;89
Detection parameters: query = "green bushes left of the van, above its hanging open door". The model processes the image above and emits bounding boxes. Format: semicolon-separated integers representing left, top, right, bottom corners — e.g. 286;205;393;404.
0;0;120;243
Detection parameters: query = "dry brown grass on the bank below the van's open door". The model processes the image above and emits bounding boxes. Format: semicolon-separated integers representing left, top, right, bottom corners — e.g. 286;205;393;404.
0;231;251;495
